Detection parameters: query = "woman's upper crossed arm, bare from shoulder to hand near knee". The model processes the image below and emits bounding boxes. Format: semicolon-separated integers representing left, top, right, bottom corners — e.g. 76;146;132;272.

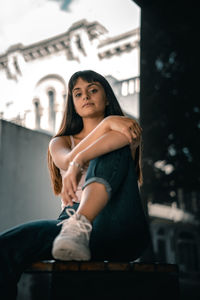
49;116;141;170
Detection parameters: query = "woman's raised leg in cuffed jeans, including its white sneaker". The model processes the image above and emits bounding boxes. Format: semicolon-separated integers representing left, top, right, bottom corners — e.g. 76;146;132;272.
52;146;149;260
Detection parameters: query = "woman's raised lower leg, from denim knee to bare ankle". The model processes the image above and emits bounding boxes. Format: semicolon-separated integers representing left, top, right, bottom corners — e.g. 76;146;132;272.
77;147;128;222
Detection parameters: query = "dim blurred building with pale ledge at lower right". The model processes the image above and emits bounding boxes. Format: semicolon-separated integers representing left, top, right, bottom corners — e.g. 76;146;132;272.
148;200;200;290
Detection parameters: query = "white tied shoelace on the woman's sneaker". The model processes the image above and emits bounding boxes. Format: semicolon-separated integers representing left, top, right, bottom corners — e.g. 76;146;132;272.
57;208;92;239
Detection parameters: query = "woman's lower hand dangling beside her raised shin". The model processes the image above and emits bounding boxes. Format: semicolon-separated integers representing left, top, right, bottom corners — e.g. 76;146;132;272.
61;165;82;206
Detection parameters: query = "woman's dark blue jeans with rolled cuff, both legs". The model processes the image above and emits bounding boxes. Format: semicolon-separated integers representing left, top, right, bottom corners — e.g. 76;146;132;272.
0;146;150;299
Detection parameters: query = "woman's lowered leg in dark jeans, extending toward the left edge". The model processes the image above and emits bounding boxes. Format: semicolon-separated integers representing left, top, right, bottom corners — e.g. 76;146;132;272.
0;204;78;299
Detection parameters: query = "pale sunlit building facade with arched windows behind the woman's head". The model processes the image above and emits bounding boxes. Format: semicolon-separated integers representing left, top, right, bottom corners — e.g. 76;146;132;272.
0;20;140;133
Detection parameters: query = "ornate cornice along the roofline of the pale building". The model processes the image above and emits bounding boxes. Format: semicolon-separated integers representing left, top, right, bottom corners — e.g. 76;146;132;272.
0;19;140;69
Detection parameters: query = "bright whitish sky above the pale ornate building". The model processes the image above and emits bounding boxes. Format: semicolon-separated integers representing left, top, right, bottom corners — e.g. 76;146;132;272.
0;0;140;54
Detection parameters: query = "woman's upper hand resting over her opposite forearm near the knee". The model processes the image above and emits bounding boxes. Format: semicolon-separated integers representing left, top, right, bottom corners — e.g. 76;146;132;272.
104;115;142;144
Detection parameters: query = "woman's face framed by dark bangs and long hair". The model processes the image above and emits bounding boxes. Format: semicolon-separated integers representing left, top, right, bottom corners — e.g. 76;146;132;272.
72;78;107;118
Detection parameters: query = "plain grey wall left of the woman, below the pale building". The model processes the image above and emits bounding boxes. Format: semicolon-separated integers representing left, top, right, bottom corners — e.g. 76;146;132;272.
0;120;60;231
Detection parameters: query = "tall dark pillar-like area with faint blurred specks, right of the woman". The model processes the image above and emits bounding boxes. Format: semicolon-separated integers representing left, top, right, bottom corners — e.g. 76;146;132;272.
134;0;200;203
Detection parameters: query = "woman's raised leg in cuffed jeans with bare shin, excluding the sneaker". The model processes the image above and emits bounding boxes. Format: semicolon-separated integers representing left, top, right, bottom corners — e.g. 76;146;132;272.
78;146;150;260
